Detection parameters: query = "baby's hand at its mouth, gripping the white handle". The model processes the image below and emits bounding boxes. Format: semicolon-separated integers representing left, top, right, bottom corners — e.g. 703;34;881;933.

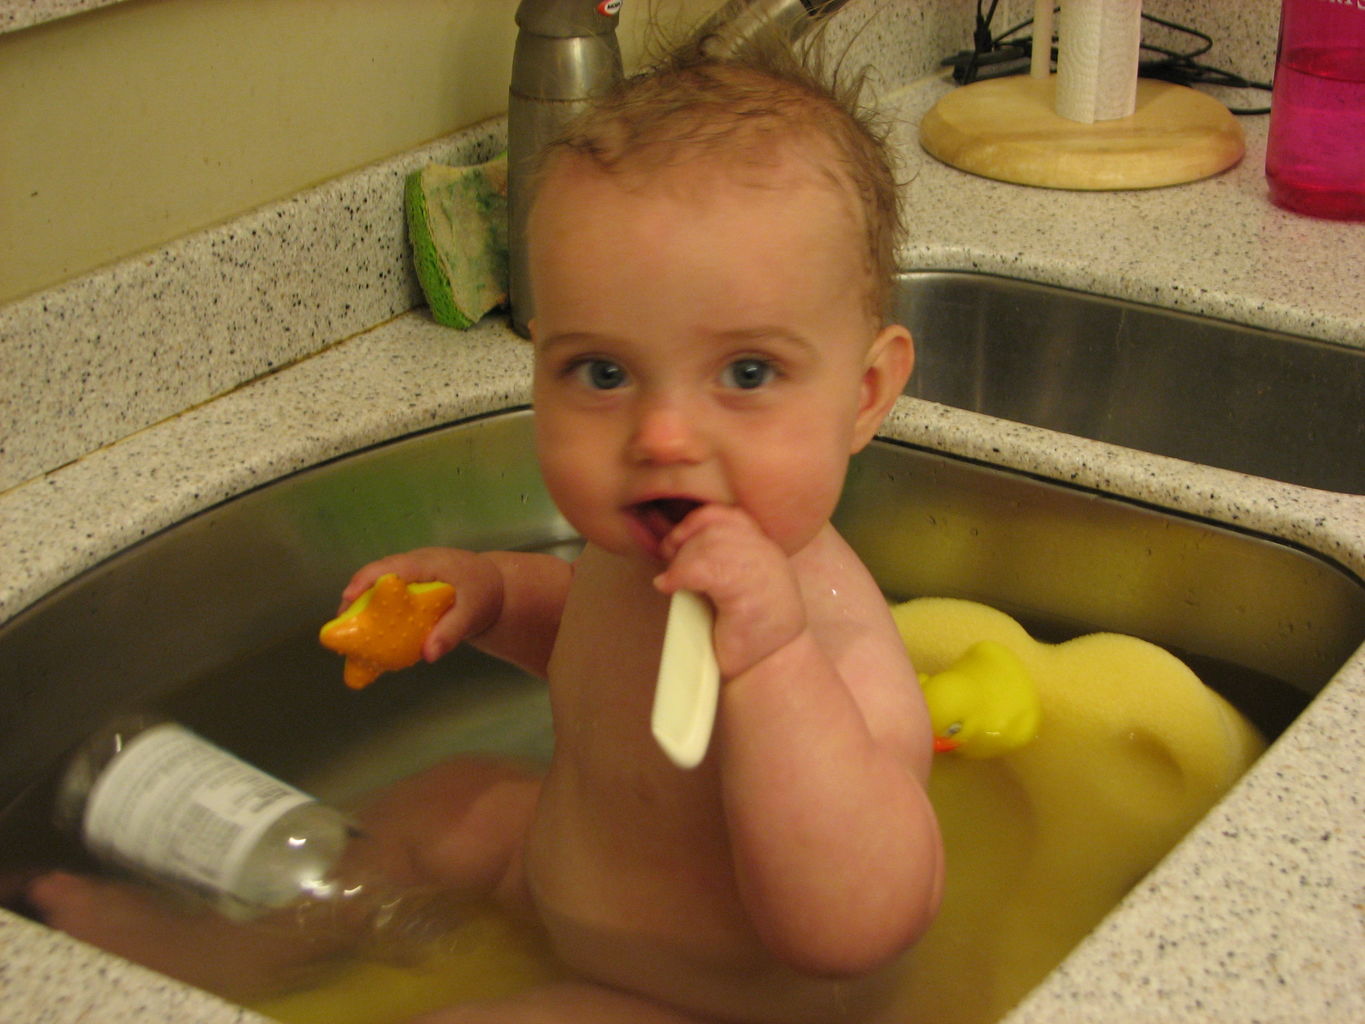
654;505;805;679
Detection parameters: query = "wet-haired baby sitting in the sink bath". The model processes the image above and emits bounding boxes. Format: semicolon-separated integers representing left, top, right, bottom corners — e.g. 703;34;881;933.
29;32;942;1024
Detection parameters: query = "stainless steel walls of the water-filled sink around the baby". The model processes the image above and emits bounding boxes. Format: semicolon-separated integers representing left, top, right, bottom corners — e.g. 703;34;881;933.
0;411;1365;1024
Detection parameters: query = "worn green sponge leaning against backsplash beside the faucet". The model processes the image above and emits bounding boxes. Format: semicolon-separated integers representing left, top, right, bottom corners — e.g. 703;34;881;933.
403;153;508;329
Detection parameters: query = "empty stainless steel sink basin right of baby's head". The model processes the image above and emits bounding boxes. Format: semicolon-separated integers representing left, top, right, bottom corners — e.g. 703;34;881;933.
895;272;1365;494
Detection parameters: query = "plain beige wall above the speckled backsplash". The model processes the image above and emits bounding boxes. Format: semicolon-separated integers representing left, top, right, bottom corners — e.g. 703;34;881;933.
0;0;710;302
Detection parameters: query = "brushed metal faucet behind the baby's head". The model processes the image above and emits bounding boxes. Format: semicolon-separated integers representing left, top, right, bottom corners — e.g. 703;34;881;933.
508;0;846;335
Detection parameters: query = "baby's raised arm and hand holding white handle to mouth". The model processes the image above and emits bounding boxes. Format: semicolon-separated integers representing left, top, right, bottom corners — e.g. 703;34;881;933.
659;505;942;973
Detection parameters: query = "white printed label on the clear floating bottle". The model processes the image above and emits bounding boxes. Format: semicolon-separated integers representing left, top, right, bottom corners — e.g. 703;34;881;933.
82;724;313;896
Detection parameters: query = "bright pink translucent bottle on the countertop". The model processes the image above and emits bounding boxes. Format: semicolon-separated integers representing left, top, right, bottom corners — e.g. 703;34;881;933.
1265;0;1365;220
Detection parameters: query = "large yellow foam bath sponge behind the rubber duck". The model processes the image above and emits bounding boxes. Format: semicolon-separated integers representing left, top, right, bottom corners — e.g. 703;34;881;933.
893;598;1264;1024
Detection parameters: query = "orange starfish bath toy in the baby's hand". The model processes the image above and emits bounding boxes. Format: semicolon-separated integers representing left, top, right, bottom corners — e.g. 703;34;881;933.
318;572;455;689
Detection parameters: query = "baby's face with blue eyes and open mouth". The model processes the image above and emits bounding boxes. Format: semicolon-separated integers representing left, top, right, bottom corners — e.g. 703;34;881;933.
531;157;908;557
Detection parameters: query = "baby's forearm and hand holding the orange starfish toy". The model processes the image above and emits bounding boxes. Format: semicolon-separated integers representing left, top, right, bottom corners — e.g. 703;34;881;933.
341;547;573;677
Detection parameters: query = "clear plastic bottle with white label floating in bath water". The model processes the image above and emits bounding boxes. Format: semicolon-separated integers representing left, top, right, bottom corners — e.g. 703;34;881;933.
56;715;459;958
